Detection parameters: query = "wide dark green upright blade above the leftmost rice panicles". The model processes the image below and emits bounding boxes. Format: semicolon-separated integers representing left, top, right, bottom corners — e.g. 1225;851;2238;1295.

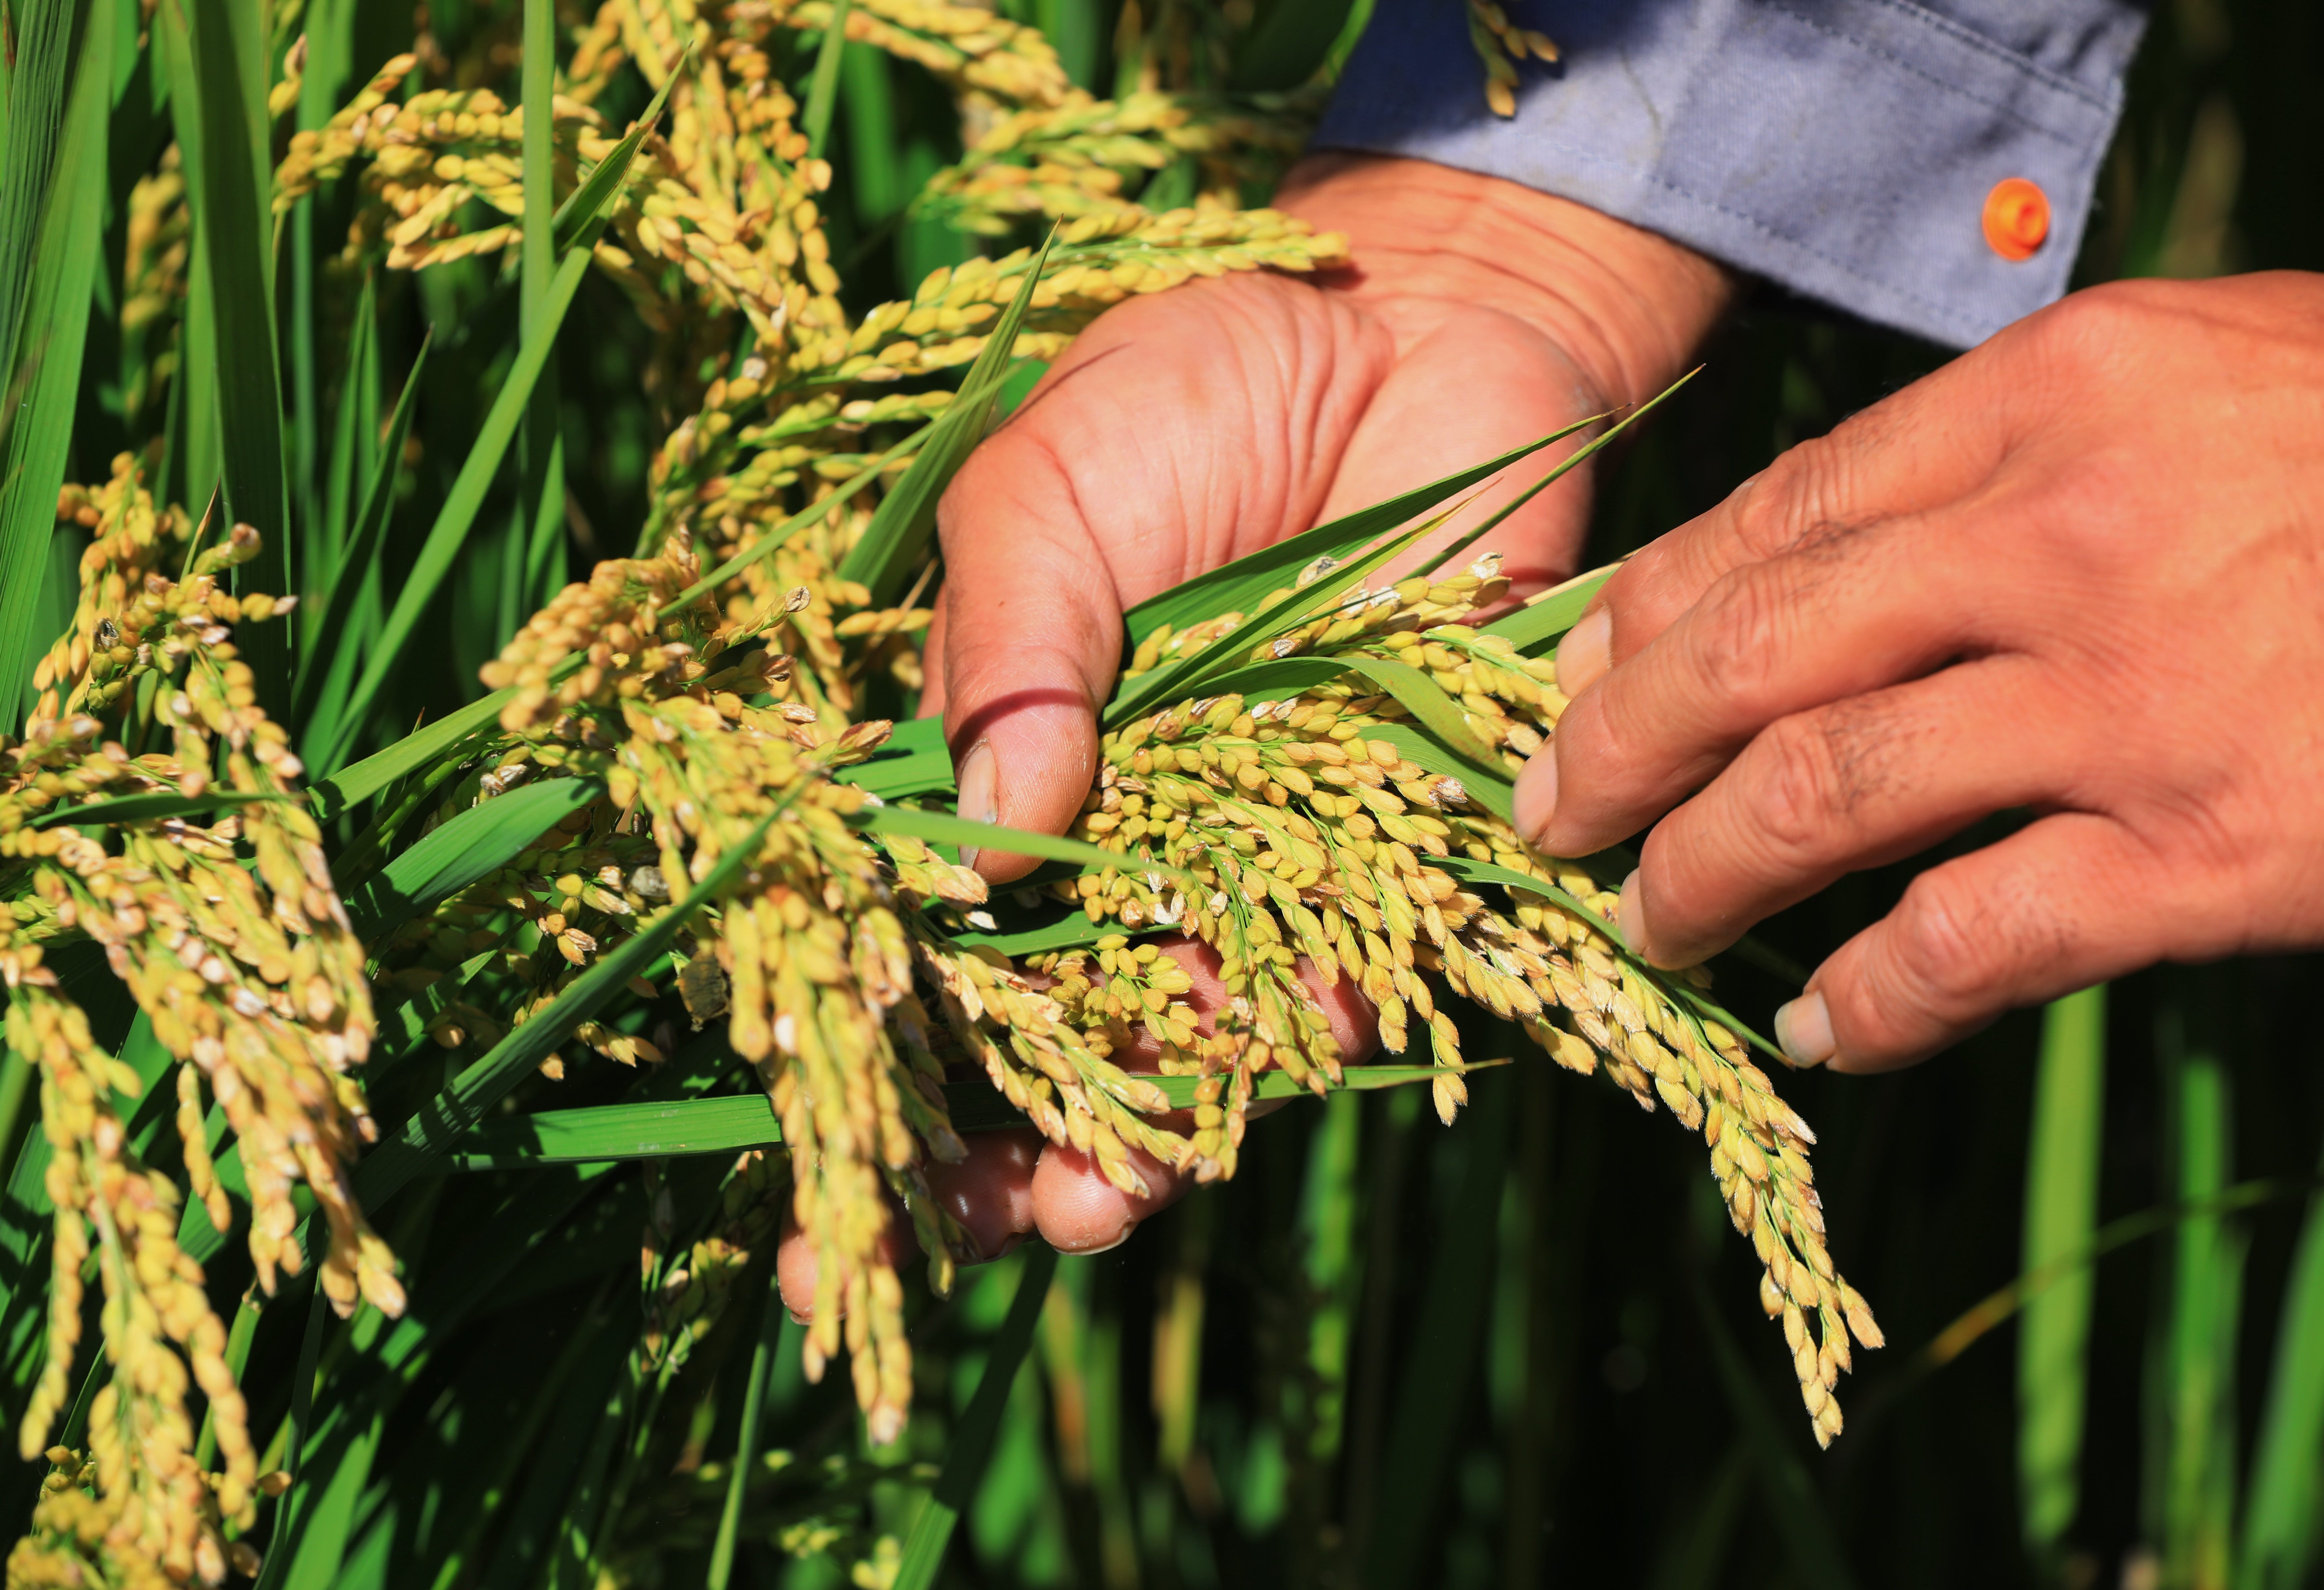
167;0;298;721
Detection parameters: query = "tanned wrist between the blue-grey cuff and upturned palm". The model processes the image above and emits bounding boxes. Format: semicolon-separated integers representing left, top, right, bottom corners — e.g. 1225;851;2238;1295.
1276;153;1738;404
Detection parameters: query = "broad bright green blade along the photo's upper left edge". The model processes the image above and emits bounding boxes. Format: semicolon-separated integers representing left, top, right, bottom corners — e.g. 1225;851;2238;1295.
0;0;108;730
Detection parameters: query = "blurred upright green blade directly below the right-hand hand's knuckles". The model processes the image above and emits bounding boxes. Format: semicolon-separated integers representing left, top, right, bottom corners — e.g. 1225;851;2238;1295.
2017;986;2106;1562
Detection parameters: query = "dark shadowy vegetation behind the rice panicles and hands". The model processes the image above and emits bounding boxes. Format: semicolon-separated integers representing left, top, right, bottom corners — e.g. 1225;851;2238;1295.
27;0;2324;1590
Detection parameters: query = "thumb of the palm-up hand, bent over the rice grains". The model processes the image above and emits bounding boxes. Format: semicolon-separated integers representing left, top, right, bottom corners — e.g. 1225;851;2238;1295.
937;416;1123;883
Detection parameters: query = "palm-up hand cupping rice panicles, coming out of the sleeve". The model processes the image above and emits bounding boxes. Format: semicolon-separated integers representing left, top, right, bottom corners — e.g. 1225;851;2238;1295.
783;156;1731;1299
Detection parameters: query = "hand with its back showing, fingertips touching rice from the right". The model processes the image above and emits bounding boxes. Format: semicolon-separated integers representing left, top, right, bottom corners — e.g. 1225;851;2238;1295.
1518;272;2324;1072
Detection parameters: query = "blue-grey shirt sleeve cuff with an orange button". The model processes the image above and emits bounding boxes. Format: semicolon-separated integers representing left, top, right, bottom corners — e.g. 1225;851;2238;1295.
1316;0;2145;346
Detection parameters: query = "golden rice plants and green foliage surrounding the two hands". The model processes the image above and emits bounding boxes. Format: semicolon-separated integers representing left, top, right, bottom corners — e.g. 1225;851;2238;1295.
0;0;2324;1590
